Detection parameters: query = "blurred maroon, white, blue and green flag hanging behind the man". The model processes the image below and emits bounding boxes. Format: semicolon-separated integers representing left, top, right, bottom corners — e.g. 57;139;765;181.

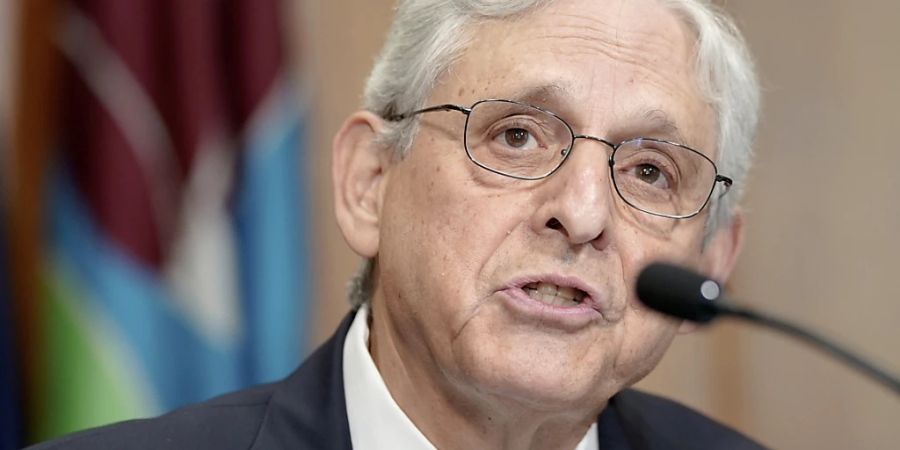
9;0;311;439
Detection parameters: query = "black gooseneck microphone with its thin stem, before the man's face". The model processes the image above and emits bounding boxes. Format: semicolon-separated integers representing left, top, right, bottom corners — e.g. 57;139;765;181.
636;263;900;395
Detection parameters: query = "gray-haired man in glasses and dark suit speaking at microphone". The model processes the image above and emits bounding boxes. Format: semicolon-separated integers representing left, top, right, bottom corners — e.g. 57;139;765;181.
33;0;758;449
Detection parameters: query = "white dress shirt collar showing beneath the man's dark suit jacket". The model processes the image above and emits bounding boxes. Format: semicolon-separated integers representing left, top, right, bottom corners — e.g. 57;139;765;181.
344;305;600;450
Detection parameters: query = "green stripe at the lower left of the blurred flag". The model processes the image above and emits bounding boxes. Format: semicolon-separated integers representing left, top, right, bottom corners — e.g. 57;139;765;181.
35;264;158;440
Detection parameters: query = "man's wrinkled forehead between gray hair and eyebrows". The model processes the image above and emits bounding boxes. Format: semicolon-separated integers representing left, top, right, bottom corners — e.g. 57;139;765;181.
432;0;712;146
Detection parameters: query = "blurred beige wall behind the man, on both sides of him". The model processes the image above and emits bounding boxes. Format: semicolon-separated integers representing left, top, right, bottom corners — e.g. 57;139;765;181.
306;0;900;449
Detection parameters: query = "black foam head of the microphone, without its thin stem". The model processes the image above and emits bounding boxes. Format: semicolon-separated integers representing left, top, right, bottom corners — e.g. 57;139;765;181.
636;263;721;323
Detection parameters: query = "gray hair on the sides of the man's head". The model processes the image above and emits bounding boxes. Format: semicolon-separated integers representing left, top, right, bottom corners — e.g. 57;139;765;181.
349;0;760;307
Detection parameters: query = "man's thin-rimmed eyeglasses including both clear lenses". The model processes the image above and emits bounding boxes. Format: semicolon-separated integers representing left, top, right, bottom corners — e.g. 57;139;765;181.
387;99;733;219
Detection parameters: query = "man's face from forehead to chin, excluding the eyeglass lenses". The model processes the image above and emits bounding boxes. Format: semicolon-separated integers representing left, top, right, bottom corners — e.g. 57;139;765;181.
373;0;728;409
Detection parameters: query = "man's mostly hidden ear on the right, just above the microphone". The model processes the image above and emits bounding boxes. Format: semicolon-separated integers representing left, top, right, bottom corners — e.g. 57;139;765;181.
678;211;744;333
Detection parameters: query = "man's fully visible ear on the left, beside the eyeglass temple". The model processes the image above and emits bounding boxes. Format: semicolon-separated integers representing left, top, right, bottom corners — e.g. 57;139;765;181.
332;111;390;258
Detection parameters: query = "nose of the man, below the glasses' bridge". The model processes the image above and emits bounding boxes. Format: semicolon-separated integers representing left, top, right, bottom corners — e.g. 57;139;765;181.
532;139;613;249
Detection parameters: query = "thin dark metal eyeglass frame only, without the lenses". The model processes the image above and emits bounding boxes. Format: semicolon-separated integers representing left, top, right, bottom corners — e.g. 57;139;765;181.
385;98;734;219
